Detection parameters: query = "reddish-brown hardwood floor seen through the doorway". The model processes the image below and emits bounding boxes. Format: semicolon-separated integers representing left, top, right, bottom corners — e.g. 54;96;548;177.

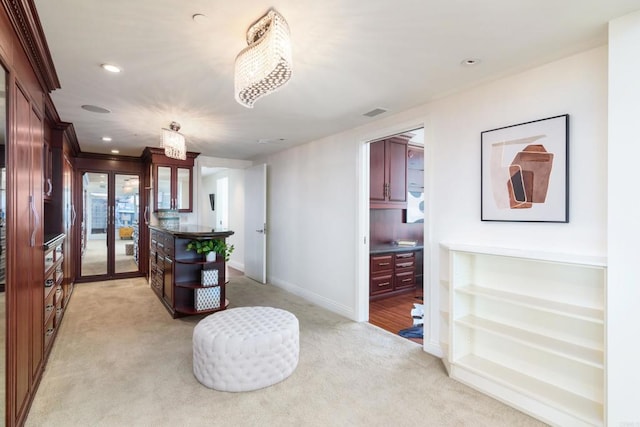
369;289;423;344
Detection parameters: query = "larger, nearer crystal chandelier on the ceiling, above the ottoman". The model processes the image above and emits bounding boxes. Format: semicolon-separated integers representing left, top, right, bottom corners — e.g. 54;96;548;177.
235;9;291;108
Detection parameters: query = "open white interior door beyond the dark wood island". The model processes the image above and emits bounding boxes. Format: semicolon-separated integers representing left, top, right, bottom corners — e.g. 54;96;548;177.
244;164;267;283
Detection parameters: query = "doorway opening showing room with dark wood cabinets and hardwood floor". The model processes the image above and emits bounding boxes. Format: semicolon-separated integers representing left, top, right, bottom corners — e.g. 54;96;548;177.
369;128;425;344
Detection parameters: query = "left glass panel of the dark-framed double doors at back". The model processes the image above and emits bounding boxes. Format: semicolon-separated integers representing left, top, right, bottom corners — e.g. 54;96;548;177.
80;172;109;276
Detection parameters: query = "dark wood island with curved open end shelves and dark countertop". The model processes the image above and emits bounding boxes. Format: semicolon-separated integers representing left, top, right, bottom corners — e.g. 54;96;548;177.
149;225;234;318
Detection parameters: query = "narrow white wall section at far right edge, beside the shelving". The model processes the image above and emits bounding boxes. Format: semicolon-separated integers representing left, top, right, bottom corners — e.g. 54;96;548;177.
607;12;640;426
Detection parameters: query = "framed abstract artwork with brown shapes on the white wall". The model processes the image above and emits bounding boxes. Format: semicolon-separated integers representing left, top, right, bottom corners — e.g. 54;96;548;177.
480;114;569;222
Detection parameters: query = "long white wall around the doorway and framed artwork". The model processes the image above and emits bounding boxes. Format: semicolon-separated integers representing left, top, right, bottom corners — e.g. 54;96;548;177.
267;47;607;320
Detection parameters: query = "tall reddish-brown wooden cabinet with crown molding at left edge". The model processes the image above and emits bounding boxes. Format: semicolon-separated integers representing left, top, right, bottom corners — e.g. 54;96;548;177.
0;1;69;427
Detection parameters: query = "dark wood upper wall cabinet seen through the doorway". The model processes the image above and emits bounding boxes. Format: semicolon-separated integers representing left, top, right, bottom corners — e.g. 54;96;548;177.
369;136;407;209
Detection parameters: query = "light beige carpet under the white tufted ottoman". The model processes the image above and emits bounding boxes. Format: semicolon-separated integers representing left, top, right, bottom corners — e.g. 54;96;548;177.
26;277;542;427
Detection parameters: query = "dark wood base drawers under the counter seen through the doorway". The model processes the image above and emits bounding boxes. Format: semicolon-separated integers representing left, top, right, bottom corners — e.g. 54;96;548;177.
369;249;422;300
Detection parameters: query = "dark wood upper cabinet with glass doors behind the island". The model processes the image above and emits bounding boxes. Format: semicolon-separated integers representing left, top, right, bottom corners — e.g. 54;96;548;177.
143;147;199;212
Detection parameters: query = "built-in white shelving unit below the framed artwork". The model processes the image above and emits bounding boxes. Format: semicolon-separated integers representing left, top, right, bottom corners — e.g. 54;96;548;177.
443;245;606;426
